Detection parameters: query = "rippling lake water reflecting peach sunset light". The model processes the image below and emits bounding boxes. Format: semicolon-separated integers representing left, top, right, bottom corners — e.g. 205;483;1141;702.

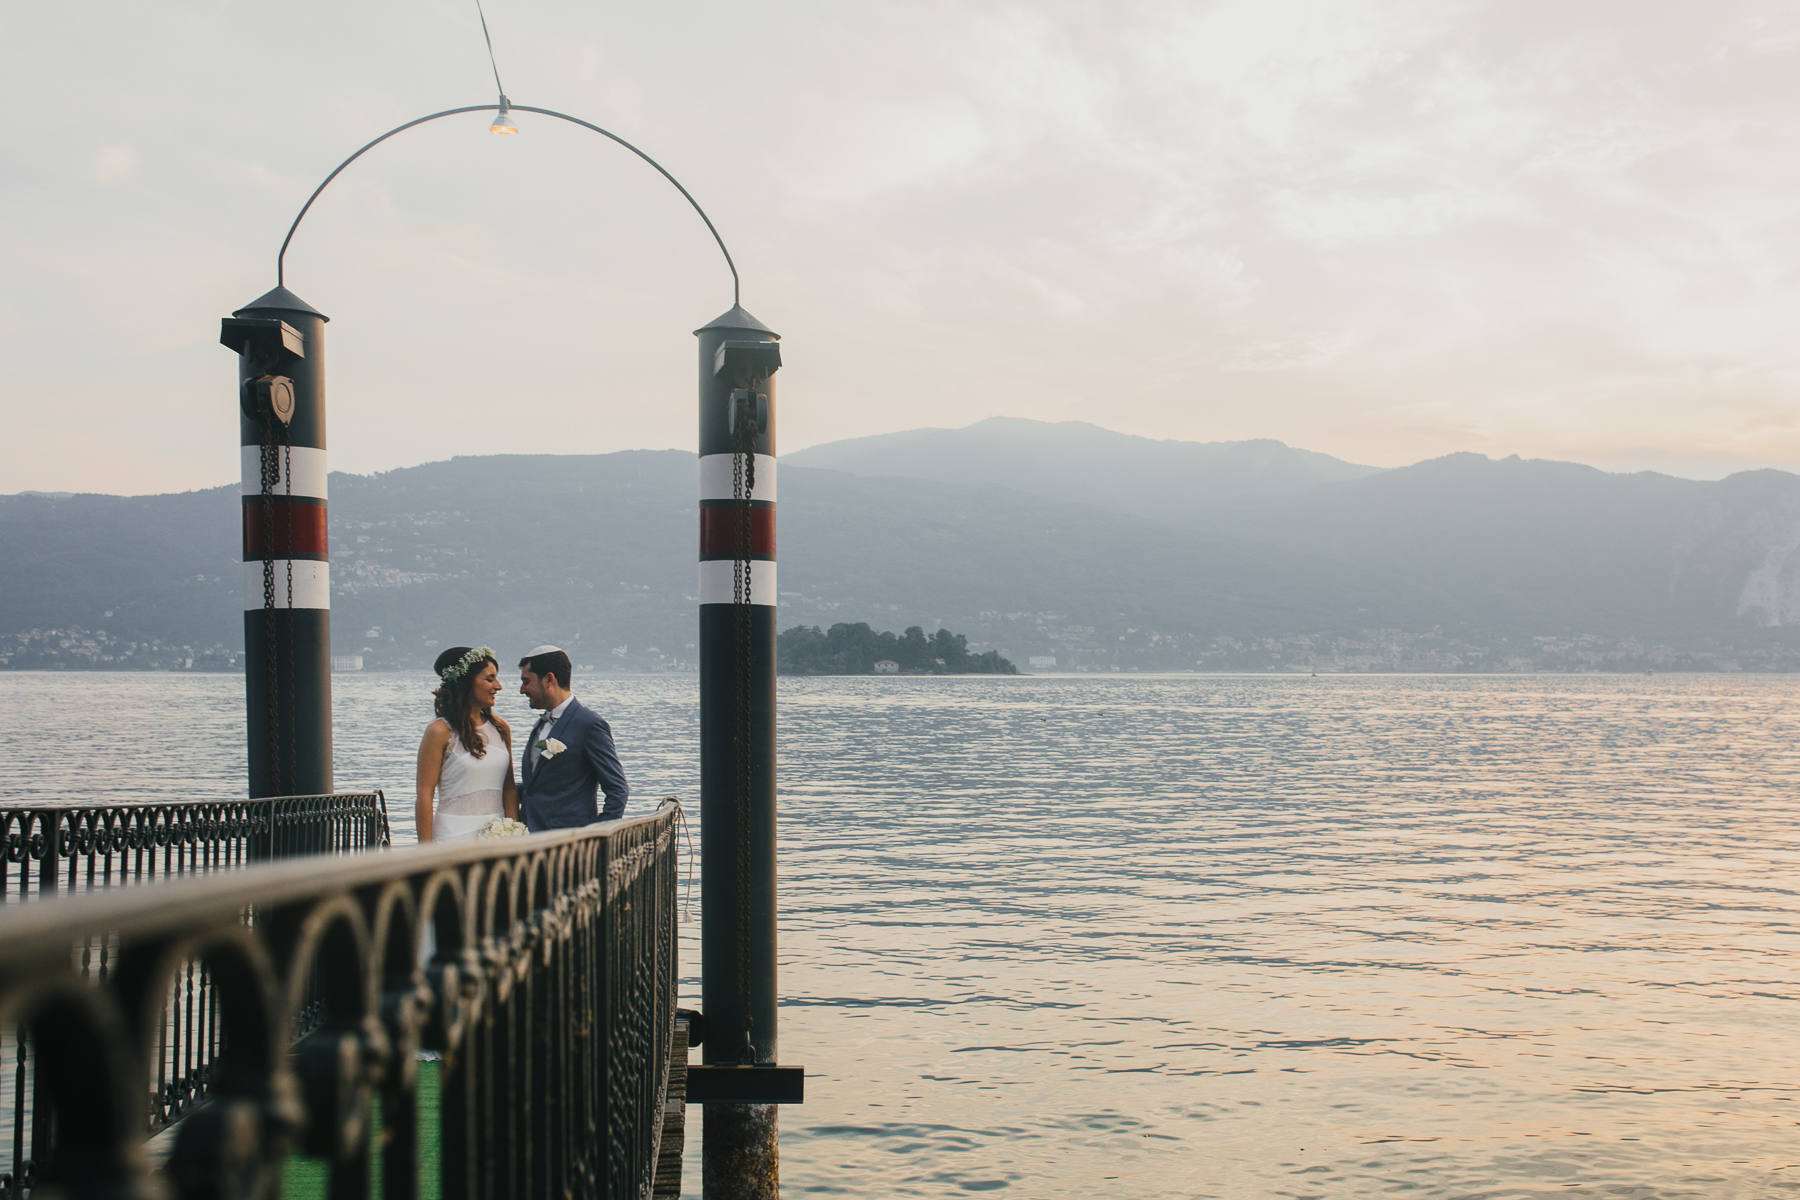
0;675;1800;1198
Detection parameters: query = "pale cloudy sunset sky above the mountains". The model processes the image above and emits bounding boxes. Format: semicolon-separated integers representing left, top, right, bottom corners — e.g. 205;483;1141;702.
0;0;1800;493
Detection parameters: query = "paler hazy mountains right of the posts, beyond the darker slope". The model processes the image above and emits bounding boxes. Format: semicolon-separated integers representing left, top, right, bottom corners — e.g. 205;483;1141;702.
792;419;1800;664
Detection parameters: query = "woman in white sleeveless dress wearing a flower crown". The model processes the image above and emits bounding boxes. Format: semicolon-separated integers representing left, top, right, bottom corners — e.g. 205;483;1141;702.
412;646;518;842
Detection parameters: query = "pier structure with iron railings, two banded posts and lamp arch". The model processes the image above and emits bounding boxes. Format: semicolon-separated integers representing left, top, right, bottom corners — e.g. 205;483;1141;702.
0;70;788;1200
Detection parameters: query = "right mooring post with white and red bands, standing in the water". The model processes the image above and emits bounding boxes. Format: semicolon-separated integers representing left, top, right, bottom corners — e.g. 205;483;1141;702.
695;306;781;1200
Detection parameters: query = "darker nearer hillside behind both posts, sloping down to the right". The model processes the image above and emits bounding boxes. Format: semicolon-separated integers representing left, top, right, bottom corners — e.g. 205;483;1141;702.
0;452;1420;667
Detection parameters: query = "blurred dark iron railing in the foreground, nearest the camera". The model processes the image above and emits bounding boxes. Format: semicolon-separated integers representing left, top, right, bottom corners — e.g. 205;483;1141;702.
0;804;677;1200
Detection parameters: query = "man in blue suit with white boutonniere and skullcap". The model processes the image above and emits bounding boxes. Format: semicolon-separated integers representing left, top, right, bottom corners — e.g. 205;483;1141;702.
518;646;632;833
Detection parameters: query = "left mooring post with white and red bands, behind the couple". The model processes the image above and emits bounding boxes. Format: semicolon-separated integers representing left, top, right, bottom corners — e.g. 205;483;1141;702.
220;286;331;805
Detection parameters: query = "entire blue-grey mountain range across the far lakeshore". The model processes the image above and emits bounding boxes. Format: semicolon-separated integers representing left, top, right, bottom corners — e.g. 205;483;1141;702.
0;419;1800;671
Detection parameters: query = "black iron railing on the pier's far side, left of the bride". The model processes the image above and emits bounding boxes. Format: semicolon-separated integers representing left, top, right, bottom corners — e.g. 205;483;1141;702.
0;792;389;903
